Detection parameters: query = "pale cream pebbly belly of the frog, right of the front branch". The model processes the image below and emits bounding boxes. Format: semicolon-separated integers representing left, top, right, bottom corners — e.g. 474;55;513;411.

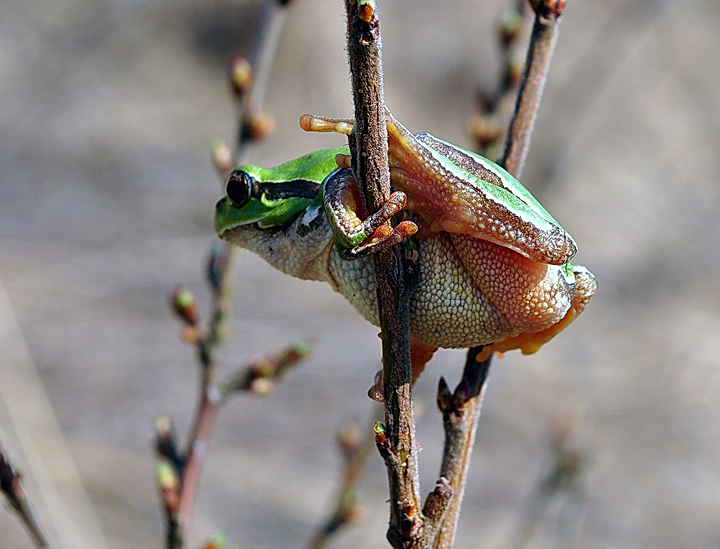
410;232;510;348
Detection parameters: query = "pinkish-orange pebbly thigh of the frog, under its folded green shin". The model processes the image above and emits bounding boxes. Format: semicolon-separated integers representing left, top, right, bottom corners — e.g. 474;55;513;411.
451;235;574;333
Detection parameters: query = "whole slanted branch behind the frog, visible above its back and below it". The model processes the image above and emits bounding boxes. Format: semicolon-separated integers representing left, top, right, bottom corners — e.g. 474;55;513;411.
423;0;565;549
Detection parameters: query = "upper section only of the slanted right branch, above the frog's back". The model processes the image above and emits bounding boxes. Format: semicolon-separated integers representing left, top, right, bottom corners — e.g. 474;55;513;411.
500;0;565;177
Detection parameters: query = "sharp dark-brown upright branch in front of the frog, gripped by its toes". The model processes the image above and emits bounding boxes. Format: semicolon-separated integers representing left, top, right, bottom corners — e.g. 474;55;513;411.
345;0;422;547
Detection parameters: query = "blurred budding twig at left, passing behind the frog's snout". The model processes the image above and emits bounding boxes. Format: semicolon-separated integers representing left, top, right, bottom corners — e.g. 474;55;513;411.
156;0;296;549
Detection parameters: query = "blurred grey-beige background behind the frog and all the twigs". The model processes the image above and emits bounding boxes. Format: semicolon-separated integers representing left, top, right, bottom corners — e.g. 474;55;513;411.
0;0;720;549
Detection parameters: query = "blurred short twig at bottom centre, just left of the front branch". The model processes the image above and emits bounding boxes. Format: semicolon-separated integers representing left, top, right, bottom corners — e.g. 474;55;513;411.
307;414;380;549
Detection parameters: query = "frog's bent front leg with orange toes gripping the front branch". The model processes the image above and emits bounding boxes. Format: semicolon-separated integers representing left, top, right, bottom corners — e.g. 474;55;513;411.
322;167;418;259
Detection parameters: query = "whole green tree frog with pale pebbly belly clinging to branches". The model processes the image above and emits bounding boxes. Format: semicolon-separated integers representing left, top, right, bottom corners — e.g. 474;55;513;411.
215;112;596;358
